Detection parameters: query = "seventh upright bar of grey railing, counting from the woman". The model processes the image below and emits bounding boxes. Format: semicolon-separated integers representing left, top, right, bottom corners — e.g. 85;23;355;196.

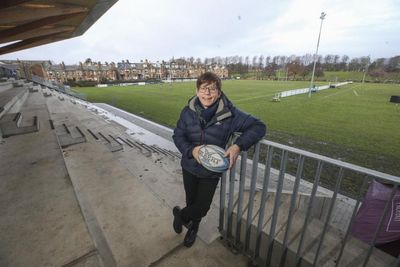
279;155;304;267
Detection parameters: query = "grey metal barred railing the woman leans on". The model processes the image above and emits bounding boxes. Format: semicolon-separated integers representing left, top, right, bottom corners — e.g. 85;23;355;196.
219;140;400;266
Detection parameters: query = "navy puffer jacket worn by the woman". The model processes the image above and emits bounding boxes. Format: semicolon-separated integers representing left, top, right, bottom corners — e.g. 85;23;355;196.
173;94;266;178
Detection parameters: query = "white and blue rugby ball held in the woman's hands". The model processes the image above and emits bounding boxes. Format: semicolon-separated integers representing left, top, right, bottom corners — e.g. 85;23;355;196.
199;145;229;172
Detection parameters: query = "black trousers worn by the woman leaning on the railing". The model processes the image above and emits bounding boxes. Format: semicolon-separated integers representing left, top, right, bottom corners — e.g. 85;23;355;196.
181;169;220;228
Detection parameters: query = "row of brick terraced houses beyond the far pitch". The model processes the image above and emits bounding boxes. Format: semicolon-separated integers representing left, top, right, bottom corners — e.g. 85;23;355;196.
0;60;229;83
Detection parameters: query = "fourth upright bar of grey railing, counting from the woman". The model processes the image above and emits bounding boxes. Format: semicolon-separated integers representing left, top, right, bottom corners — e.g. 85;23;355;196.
244;142;260;251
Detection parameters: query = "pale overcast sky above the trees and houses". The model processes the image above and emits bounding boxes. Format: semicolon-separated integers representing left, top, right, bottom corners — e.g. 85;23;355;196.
0;0;400;64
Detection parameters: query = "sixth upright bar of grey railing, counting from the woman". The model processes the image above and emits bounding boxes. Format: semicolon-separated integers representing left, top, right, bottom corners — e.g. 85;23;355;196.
266;150;288;266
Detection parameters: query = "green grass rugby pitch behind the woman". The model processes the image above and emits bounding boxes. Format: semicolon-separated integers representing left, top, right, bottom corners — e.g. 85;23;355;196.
75;80;400;185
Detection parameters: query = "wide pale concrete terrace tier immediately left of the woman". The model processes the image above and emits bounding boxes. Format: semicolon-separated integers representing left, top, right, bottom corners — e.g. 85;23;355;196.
45;91;245;266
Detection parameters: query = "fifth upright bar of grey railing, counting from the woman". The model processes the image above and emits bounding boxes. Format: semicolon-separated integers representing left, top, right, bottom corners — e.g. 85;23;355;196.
254;147;274;259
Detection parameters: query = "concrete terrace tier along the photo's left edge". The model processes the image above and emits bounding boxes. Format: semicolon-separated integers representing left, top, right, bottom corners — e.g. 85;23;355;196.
0;81;101;266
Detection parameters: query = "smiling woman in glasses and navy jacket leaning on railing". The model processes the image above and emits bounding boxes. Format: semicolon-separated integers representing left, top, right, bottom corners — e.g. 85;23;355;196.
173;72;266;247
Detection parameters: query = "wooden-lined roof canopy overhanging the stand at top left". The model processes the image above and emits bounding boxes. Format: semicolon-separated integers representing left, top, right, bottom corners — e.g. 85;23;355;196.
0;0;118;55
